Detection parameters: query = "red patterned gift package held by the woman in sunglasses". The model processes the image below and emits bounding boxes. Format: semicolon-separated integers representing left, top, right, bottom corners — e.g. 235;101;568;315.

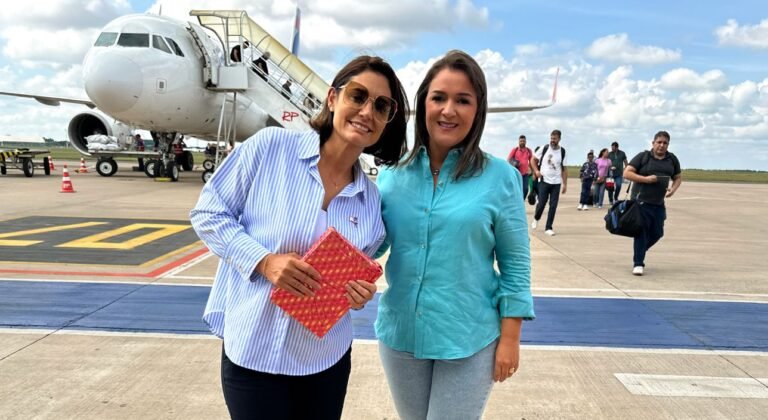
270;227;382;338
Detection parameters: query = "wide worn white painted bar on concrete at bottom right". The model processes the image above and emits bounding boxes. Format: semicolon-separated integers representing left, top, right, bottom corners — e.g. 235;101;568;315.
614;373;768;399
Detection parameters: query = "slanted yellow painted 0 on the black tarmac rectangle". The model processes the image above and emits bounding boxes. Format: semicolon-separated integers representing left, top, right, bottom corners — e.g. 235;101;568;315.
56;223;191;250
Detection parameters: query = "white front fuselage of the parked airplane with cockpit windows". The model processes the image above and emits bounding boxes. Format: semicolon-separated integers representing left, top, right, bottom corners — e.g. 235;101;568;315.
83;15;268;140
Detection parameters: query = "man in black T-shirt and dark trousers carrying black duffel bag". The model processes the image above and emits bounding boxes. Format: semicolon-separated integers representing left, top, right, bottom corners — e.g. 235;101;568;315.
624;131;683;276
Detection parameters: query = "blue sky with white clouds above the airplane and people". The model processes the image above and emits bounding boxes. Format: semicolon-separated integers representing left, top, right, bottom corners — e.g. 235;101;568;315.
0;0;768;171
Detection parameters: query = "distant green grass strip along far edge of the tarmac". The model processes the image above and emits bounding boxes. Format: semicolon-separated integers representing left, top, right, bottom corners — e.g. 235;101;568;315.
18;148;768;184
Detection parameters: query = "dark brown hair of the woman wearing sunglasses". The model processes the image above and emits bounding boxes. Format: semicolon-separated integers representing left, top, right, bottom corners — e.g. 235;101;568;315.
309;55;410;165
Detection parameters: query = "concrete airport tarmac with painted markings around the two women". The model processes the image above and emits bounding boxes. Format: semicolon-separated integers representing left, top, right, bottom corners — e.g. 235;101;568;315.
0;162;768;419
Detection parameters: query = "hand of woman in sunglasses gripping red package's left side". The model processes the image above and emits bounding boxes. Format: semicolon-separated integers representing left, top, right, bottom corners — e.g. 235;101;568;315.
256;252;320;297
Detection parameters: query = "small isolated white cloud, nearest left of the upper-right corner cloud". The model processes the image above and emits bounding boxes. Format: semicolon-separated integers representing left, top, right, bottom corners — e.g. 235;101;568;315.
587;34;681;65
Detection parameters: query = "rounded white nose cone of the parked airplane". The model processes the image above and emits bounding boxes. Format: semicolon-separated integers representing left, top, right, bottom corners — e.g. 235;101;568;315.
83;54;143;114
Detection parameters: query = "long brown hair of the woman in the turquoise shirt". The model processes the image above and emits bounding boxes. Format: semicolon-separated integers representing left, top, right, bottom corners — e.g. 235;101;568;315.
405;50;488;179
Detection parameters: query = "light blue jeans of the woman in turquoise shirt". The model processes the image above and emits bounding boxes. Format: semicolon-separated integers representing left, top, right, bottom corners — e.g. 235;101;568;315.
379;340;498;420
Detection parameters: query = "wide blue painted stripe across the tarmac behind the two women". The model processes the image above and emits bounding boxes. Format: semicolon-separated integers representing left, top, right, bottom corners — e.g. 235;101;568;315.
0;281;768;351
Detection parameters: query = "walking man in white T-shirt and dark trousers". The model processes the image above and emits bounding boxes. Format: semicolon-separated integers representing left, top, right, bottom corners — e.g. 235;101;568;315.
531;130;568;236
